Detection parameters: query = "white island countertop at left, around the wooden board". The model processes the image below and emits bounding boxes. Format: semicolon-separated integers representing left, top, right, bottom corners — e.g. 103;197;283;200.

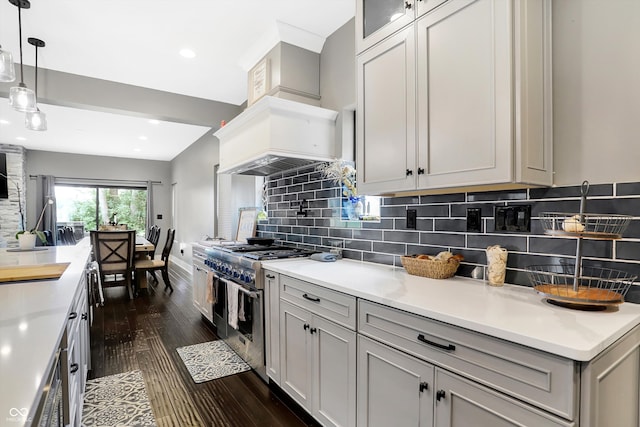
0;242;90;426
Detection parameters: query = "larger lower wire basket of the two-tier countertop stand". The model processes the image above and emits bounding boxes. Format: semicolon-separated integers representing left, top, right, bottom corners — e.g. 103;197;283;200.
526;265;637;306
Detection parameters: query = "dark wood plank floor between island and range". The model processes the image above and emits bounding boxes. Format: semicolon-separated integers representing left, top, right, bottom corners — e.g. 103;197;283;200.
89;269;314;427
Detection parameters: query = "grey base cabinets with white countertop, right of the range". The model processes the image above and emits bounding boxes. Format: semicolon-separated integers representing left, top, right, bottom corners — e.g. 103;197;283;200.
263;259;640;427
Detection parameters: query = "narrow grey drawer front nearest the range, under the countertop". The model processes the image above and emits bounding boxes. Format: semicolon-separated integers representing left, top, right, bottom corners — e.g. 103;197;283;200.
280;275;356;330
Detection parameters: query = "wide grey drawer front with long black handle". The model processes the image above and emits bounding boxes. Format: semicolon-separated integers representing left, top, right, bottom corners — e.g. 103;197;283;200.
358;300;579;420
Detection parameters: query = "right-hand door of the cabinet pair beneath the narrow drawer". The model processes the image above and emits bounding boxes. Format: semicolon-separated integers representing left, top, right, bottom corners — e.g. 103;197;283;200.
311;316;356;427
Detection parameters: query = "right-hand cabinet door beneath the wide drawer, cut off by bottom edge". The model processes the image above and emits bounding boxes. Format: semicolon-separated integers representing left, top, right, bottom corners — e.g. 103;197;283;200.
434;368;574;427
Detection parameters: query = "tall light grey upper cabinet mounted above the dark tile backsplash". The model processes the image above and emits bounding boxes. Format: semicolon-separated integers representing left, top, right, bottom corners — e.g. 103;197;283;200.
356;0;552;194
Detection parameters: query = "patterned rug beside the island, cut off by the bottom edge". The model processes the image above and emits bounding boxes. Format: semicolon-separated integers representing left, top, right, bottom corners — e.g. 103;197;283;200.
82;370;156;427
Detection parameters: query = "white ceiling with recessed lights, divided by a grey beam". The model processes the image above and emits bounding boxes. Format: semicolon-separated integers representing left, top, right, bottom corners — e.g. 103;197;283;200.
0;0;355;160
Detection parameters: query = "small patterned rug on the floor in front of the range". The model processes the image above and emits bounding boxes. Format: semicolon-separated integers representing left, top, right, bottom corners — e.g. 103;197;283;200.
176;340;251;383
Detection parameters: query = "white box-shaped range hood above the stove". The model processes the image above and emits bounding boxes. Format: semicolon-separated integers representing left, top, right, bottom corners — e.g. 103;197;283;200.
214;96;338;176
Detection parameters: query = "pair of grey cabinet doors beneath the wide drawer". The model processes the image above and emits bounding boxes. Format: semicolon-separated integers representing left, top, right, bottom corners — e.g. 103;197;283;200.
357;336;573;427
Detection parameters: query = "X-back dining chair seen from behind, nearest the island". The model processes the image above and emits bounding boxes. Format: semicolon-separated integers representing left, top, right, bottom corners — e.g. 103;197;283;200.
90;230;136;305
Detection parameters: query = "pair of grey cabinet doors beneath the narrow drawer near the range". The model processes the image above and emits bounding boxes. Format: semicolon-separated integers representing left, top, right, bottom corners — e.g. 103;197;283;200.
280;300;356;426
